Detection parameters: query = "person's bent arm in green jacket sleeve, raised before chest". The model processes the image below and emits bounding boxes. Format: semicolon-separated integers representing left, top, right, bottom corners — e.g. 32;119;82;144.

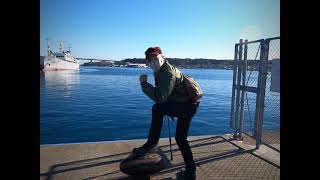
141;73;175;103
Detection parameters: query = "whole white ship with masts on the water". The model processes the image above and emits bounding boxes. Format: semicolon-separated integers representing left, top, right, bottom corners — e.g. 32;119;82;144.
40;39;80;71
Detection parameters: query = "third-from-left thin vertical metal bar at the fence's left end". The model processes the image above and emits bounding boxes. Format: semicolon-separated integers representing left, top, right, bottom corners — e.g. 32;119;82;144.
239;39;248;138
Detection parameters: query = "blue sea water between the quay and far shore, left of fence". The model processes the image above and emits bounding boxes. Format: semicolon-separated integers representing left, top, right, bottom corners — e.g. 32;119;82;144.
40;67;278;144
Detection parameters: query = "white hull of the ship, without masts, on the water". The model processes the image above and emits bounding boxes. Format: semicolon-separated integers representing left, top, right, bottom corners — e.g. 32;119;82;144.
43;56;80;71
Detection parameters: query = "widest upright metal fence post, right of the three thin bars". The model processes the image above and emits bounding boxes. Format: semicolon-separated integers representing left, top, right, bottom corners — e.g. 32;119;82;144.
255;40;270;148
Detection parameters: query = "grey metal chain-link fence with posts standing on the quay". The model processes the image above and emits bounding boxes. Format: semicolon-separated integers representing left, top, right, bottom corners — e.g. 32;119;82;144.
230;37;280;152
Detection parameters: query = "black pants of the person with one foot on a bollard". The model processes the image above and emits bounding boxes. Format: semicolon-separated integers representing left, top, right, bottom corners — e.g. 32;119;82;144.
143;102;199;171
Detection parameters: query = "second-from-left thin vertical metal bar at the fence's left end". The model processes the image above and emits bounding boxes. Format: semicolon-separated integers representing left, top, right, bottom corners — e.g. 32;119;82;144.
234;39;243;137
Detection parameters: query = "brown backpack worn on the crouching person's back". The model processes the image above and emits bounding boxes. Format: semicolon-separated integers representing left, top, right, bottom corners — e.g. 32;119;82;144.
183;75;203;103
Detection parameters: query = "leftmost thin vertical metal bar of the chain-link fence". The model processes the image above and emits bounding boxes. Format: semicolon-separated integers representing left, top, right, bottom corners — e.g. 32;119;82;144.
230;44;238;129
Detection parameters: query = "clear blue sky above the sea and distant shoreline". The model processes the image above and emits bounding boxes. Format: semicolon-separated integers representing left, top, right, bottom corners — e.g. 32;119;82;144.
40;0;280;60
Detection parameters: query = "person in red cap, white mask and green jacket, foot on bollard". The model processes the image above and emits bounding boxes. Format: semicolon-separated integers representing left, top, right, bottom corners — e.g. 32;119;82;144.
133;47;200;179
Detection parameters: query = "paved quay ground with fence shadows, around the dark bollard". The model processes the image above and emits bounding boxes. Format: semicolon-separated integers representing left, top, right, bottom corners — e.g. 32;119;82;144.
40;135;280;180
